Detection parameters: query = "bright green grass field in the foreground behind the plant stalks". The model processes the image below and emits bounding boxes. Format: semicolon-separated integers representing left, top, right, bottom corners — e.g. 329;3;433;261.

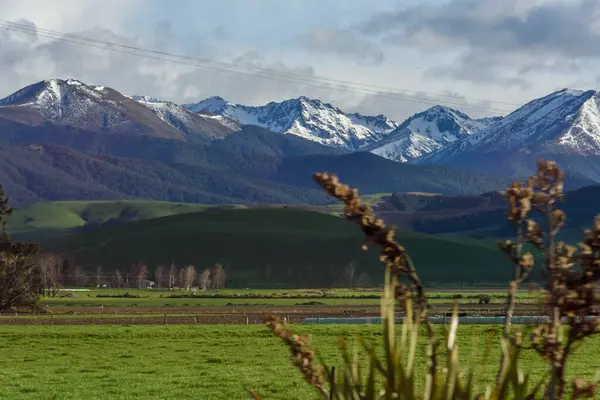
0;325;600;400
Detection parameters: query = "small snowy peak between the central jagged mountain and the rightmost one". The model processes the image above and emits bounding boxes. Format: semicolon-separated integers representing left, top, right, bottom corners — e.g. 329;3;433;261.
367;106;501;162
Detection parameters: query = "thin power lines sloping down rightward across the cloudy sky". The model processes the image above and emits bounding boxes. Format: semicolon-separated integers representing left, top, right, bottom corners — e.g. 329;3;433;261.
0;20;516;113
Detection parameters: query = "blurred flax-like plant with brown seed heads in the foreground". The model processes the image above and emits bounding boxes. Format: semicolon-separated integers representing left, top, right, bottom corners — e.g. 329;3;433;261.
249;160;600;400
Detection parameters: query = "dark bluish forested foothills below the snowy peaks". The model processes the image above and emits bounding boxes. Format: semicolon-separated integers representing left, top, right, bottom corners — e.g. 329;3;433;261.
0;119;505;205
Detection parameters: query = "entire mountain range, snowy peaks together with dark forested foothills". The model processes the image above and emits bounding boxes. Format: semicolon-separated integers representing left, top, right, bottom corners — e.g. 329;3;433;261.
0;79;600;204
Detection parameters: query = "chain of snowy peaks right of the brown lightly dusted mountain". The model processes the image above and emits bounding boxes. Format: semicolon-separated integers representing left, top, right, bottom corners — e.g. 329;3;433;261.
184;89;600;183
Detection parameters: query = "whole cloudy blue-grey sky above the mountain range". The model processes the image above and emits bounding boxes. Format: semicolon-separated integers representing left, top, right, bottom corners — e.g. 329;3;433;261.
0;0;600;119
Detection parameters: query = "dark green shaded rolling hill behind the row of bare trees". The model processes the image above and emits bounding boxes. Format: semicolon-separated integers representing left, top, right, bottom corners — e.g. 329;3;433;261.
45;208;511;287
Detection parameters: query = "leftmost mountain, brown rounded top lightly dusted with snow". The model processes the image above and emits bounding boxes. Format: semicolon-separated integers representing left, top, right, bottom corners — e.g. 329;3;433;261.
0;79;238;140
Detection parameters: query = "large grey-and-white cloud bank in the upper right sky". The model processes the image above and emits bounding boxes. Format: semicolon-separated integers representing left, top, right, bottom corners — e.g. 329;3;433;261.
361;0;600;90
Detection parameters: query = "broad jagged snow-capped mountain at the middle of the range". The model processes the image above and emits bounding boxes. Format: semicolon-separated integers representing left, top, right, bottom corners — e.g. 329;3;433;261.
184;96;399;151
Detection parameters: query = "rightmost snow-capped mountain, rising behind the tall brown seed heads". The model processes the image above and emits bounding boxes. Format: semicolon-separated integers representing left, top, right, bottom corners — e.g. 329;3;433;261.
414;89;600;181
